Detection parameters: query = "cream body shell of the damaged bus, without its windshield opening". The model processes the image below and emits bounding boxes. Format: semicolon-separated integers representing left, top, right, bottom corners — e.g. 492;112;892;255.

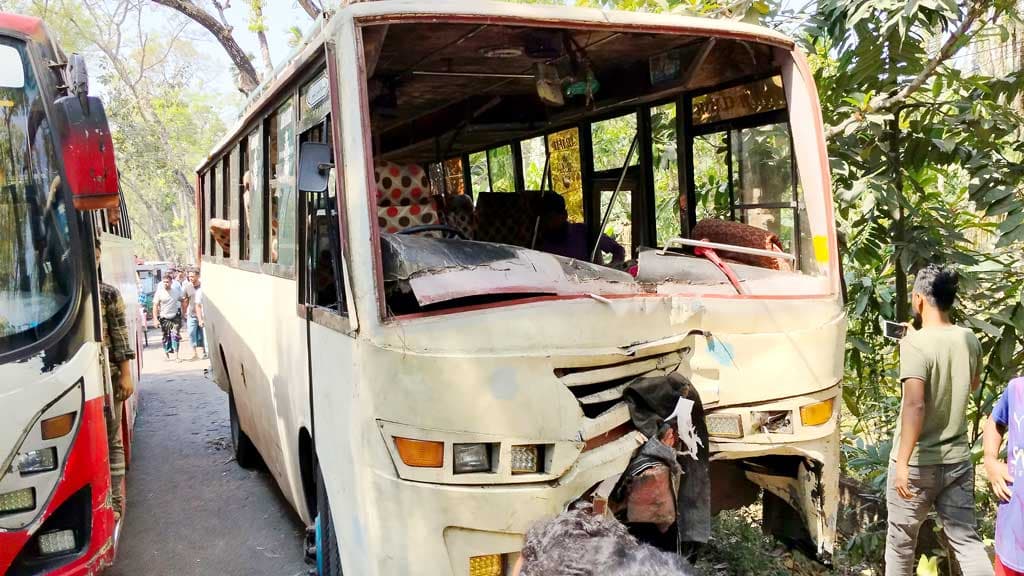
198;0;846;576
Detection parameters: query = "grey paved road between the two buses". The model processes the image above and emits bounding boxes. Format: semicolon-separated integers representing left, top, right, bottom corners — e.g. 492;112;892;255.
105;330;307;576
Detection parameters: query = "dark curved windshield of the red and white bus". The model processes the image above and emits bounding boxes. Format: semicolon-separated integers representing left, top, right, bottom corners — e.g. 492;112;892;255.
0;37;75;355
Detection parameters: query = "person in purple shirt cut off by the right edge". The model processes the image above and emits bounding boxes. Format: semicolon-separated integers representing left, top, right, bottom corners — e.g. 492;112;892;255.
984;377;1024;576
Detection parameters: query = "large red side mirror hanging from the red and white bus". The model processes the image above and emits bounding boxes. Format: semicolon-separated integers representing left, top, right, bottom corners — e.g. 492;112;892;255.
54;94;120;210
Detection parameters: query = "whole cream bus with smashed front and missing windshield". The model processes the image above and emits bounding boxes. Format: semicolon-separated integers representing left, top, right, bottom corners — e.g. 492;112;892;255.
198;0;846;576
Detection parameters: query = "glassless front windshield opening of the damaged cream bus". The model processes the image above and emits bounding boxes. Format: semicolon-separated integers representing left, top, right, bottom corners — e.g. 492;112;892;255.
364;23;835;315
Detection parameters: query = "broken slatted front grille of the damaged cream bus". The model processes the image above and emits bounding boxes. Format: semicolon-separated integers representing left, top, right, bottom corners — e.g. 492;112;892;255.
555;351;682;450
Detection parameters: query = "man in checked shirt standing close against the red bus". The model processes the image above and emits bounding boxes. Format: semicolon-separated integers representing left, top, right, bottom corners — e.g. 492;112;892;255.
96;238;135;521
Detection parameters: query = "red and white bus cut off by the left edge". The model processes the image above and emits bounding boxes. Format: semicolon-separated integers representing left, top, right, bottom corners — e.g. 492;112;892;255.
0;13;139;576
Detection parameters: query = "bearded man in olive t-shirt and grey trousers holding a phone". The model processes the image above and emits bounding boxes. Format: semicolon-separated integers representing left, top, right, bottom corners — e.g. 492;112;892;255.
886;265;993;576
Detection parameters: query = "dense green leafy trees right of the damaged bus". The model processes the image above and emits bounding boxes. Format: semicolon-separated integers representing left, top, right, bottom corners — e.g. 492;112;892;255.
802;0;1024;561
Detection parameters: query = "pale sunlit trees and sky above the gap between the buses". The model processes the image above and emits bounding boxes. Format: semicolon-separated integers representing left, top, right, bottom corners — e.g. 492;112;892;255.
20;0;229;262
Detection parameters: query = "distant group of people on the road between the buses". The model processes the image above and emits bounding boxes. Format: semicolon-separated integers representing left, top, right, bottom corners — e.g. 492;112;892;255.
153;269;207;362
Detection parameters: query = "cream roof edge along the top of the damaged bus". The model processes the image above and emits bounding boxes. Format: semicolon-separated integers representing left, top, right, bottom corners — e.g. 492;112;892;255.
196;0;795;172
